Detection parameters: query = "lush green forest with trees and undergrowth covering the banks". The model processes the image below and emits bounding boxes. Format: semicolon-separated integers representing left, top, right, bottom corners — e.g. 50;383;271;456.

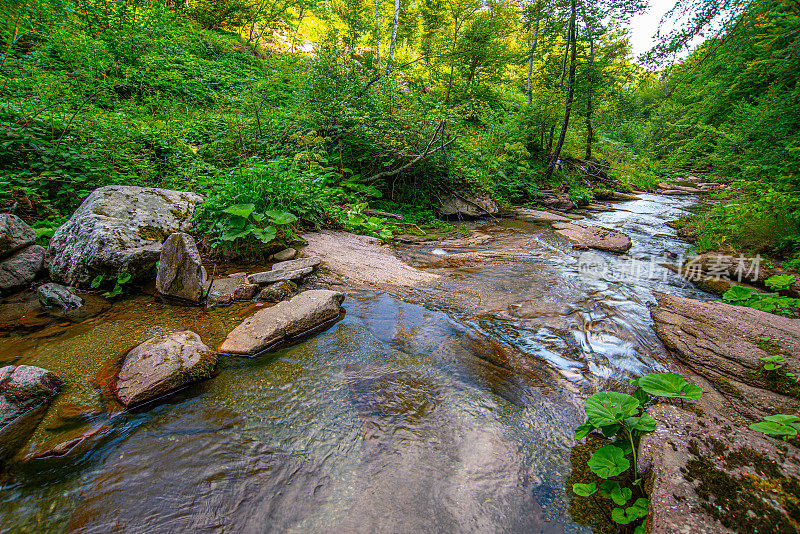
0;0;800;267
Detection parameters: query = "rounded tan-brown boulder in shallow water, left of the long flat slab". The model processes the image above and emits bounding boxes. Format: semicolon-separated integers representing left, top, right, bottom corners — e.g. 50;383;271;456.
115;330;217;406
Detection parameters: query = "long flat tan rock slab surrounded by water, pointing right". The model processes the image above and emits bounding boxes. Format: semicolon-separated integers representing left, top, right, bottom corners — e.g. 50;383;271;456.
218;289;344;355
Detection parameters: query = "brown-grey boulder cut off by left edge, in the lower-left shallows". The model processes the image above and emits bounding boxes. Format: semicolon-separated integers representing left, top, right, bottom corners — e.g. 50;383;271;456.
0;365;62;465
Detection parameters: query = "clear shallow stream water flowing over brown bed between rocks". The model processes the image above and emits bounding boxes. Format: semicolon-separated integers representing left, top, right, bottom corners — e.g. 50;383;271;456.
0;196;708;533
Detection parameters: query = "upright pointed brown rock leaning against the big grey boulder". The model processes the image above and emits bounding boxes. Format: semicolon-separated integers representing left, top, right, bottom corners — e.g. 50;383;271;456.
156;232;204;302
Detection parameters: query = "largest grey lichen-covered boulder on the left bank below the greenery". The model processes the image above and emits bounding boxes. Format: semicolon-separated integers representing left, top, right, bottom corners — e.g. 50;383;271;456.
47;185;203;287
